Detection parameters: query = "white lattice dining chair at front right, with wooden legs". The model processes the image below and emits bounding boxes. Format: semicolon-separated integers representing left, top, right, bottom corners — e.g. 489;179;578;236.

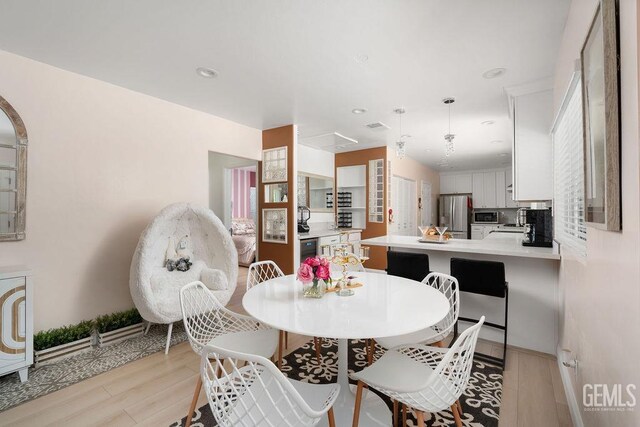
351;316;484;427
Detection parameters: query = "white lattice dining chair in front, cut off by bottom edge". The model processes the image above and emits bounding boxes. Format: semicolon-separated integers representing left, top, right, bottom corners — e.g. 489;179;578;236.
200;345;340;427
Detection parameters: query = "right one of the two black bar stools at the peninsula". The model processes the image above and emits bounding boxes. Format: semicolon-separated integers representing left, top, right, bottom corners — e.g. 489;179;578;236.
451;258;509;368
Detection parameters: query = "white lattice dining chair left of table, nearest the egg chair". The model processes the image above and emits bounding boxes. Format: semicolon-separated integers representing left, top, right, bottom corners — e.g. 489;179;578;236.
180;282;278;427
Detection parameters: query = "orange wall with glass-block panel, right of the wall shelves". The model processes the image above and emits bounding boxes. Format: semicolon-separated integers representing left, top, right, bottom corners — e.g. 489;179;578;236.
334;147;389;270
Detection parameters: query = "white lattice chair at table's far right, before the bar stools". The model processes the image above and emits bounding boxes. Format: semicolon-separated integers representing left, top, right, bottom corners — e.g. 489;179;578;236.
376;272;460;349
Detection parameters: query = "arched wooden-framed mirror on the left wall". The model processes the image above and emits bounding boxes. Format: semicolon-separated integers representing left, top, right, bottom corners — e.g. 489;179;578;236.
0;96;27;241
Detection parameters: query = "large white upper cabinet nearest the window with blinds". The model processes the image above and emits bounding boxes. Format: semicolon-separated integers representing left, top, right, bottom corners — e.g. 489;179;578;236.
513;90;553;200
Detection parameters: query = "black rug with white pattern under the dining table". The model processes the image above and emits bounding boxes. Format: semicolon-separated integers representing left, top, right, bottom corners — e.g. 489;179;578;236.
170;339;502;427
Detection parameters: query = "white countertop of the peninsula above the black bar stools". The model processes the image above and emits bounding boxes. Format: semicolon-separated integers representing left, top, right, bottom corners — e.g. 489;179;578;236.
362;233;560;260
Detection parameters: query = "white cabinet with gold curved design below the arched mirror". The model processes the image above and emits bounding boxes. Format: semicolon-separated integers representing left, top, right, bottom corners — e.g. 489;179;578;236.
0;267;33;382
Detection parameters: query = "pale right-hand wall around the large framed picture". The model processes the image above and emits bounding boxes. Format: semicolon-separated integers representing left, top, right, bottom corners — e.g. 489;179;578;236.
554;0;640;427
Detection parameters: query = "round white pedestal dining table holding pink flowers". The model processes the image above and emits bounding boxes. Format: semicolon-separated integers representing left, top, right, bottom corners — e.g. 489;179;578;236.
242;272;449;427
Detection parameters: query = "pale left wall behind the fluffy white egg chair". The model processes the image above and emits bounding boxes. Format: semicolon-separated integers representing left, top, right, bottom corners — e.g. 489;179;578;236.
0;51;262;330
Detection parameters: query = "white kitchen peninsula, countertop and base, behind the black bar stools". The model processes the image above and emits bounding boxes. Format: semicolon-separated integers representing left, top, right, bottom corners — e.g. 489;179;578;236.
362;232;560;354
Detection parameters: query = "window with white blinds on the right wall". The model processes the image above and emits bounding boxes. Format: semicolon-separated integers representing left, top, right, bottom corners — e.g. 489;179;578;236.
552;73;587;256
